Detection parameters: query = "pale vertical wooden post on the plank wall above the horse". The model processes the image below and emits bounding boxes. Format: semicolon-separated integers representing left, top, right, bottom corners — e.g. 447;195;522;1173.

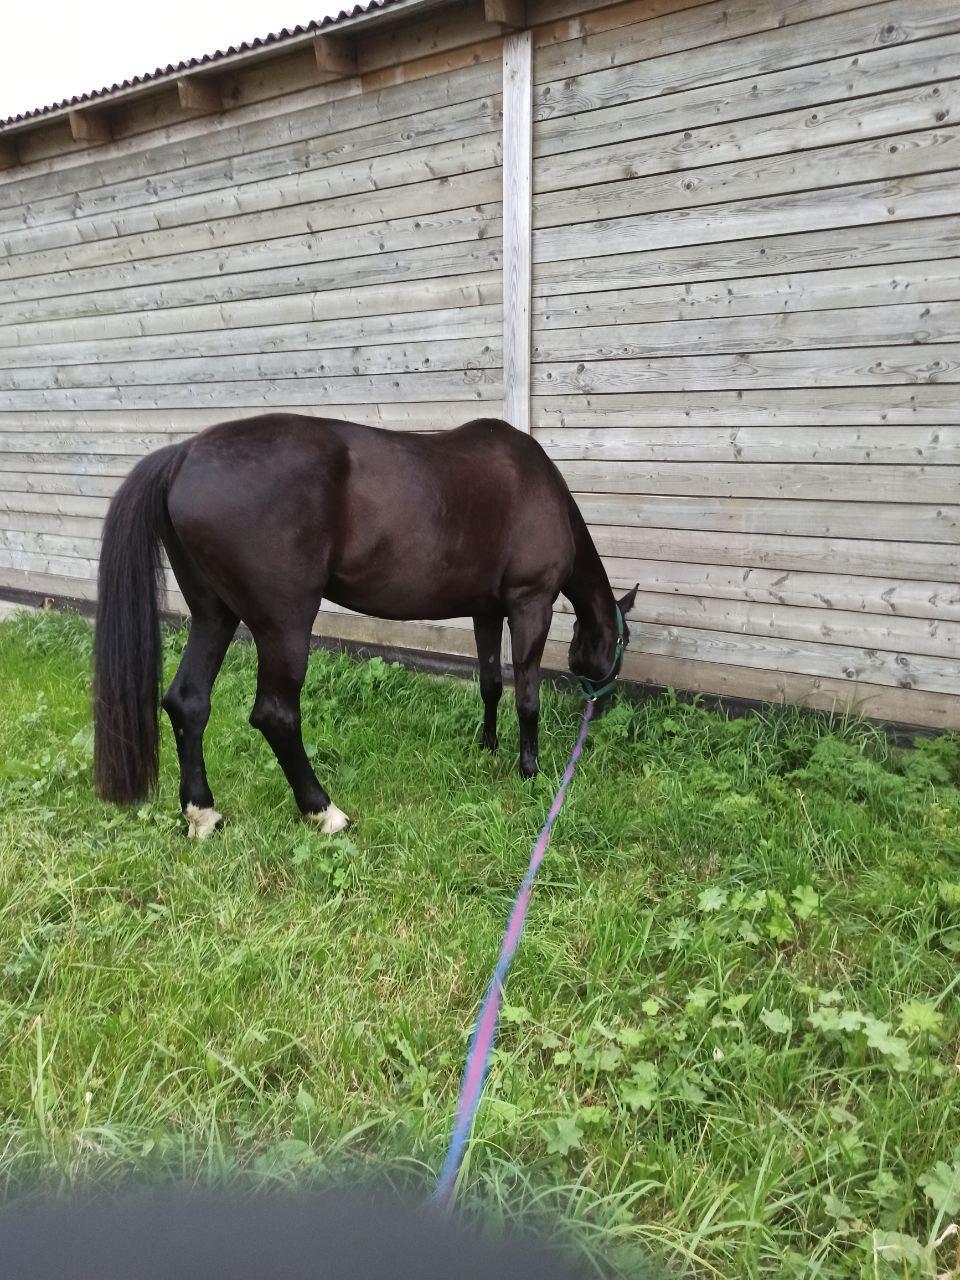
503;31;534;431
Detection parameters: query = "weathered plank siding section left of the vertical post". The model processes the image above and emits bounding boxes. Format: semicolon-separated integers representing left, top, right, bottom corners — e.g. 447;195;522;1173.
0;4;512;643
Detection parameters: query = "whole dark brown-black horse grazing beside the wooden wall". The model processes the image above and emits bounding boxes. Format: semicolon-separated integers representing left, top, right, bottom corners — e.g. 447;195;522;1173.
93;413;636;836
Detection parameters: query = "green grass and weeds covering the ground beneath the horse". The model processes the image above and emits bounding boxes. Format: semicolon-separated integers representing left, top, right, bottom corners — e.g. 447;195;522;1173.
0;614;960;1277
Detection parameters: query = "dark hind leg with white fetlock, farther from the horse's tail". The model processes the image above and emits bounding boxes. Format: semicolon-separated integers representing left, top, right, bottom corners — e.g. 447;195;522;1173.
250;622;349;835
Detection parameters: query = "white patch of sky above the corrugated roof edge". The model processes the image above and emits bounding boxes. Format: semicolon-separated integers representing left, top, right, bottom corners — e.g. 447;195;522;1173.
0;0;353;119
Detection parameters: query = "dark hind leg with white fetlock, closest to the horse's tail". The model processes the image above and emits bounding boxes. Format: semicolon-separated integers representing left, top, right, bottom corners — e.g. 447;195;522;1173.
164;591;237;838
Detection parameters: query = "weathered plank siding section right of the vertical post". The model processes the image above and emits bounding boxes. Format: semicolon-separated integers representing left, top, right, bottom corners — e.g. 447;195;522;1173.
532;0;960;727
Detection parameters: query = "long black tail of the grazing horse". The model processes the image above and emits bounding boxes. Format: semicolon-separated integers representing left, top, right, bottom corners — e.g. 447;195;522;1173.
93;444;184;804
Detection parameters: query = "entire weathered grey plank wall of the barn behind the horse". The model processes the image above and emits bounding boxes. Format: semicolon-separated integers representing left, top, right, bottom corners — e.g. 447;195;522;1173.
0;0;960;727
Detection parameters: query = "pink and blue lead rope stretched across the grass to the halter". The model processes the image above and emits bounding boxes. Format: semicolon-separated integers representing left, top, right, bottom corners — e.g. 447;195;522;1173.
431;698;595;1210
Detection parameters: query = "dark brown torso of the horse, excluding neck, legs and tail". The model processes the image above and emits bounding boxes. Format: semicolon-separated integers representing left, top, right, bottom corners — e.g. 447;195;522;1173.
168;413;573;617
